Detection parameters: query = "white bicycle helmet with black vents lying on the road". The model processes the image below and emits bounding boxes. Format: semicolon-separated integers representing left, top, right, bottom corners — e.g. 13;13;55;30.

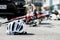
7;19;26;34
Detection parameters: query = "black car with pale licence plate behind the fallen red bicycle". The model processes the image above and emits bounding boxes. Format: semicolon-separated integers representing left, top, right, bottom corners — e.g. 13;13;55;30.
0;0;26;19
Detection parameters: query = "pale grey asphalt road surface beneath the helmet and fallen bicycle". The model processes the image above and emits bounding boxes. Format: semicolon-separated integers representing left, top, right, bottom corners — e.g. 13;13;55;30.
0;20;60;40
